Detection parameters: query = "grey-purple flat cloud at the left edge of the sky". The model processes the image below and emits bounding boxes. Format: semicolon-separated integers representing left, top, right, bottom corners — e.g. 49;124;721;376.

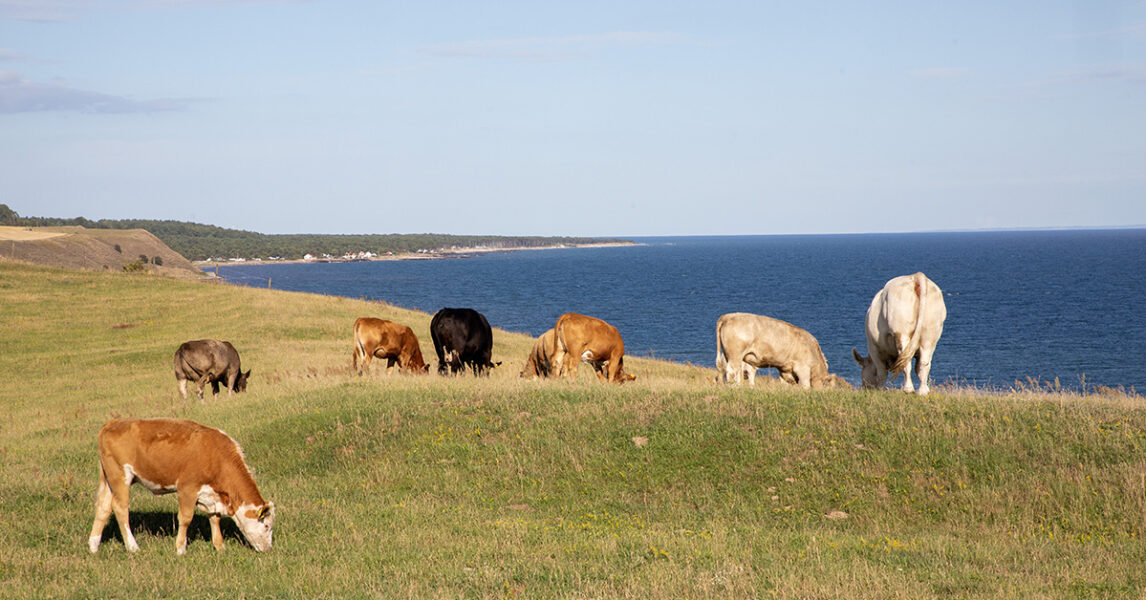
0;71;190;115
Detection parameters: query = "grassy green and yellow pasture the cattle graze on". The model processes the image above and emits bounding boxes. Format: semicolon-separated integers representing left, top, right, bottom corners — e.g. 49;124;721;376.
0;262;1146;599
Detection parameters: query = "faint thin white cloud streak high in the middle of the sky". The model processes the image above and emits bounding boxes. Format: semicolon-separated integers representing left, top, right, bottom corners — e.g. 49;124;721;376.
418;31;688;61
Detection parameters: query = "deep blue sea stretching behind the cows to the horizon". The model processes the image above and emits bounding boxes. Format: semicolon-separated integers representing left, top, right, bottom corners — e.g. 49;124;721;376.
219;229;1146;393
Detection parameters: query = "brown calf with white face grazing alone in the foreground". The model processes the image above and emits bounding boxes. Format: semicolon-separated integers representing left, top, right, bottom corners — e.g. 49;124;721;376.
87;419;275;554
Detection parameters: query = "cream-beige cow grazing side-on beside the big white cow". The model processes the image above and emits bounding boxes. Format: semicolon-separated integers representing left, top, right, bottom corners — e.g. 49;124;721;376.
716;313;851;389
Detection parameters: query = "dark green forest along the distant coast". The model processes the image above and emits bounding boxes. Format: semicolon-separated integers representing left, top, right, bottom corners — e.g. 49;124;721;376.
0;204;629;260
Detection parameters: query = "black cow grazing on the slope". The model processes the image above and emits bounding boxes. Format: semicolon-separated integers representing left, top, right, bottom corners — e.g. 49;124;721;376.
430;308;501;376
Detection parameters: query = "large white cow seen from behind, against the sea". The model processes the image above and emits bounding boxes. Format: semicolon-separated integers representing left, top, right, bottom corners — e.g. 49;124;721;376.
851;273;947;396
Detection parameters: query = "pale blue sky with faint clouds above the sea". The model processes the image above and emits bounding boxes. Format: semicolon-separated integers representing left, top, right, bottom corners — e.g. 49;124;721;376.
0;0;1146;236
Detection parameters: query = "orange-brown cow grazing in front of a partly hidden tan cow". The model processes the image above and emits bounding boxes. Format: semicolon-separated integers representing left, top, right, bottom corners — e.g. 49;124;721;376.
554;313;636;384
